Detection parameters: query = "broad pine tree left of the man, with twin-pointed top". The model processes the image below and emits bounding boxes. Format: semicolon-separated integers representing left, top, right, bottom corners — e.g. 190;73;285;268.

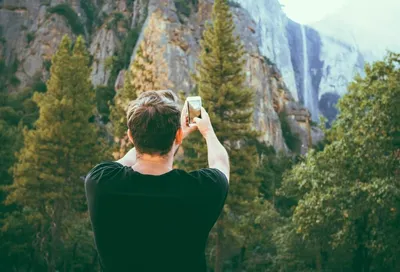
6;36;100;271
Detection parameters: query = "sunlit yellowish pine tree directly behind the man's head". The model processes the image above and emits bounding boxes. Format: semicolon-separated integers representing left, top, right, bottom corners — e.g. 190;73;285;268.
111;35;171;158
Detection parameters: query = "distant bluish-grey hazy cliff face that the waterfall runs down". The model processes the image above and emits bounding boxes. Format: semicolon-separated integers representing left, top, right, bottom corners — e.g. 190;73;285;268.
237;0;364;121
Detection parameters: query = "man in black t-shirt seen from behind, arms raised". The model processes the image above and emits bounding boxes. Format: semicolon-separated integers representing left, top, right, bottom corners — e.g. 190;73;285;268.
85;91;229;272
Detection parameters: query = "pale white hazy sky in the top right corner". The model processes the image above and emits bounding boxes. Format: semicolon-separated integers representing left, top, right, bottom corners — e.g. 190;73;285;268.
279;0;400;56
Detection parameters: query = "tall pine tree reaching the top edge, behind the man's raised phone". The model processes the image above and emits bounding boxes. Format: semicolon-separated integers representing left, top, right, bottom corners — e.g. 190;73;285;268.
184;0;263;272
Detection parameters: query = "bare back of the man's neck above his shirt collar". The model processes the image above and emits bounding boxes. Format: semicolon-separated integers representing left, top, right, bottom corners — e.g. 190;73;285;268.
132;154;174;175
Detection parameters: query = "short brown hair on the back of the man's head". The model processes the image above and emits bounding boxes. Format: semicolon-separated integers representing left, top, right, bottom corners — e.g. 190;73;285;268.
127;90;181;156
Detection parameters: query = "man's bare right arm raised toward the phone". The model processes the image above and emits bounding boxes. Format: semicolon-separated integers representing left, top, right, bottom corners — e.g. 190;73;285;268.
194;108;230;181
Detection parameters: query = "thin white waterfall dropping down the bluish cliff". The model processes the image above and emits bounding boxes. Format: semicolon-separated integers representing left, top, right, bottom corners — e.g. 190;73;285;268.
300;25;318;121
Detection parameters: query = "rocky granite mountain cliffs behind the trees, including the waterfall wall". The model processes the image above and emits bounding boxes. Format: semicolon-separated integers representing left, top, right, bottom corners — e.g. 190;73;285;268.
6;0;382;152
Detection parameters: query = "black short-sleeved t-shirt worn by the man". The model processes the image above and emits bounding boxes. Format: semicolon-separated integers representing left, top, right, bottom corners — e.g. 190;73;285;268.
85;162;228;272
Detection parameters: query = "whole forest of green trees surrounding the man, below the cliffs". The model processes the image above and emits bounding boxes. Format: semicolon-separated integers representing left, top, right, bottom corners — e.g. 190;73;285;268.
0;0;400;272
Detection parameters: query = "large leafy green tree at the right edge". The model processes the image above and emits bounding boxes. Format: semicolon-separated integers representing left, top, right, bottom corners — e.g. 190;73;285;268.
282;53;400;271
